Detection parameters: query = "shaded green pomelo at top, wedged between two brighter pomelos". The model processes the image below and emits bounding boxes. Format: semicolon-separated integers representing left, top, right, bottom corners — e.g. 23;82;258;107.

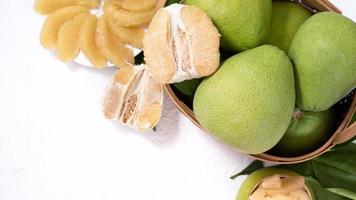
267;1;311;52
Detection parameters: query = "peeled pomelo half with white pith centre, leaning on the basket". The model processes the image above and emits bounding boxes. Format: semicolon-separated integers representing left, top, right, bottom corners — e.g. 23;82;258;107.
143;4;220;83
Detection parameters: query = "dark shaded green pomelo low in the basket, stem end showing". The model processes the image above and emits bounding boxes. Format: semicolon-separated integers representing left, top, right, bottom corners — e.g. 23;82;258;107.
272;110;335;156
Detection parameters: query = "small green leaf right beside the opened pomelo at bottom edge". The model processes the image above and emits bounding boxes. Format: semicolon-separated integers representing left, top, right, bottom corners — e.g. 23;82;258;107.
305;177;348;200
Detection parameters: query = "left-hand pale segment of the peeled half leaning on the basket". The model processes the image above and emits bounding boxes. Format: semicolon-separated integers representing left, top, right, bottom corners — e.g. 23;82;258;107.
143;9;175;83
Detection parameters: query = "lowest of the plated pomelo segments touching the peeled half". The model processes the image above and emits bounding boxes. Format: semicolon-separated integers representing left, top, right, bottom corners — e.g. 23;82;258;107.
106;16;145;49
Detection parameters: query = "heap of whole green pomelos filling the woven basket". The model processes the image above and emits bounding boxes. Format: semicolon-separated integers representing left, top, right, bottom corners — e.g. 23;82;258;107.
165;0;356;156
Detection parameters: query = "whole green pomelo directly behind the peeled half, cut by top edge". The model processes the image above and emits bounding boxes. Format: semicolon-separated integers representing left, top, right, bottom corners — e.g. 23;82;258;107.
184;0;272;52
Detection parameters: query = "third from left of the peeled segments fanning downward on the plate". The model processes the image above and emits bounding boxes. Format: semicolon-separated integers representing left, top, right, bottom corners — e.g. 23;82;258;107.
79;15;106;68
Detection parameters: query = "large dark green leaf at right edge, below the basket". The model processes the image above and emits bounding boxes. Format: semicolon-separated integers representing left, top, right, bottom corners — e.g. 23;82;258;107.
312;143;356;192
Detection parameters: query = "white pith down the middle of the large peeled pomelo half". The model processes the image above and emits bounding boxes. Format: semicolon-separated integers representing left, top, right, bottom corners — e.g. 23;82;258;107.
164;4;202;83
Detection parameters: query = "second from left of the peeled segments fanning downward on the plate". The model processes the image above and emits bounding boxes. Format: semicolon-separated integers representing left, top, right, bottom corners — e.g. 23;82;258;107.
57;13;89;62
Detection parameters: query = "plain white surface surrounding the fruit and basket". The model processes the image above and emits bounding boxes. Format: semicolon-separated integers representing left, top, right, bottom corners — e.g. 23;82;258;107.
0;0;356;200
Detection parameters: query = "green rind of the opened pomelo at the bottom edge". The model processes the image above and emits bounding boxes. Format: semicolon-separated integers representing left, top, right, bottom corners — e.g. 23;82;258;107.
236;168;315;200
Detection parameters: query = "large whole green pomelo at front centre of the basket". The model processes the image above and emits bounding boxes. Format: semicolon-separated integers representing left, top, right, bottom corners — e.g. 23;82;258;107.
193;45;295;154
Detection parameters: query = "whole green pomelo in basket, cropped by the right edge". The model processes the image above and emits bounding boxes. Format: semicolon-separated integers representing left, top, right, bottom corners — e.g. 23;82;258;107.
289;12;356;111
